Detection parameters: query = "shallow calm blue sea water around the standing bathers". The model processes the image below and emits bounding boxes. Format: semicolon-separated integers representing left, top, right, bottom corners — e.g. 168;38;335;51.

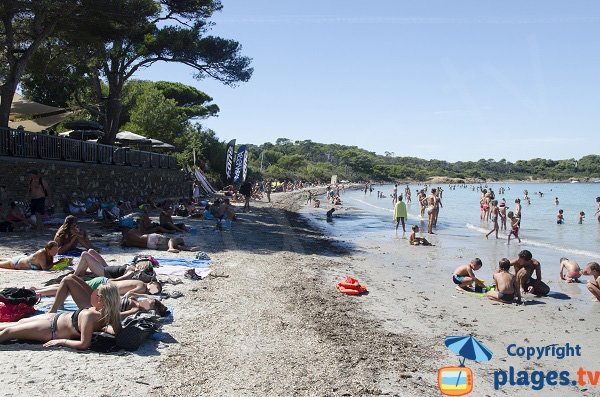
302;182;600;300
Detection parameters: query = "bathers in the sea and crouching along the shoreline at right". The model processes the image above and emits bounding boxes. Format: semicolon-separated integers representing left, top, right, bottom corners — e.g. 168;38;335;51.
364;184;600;303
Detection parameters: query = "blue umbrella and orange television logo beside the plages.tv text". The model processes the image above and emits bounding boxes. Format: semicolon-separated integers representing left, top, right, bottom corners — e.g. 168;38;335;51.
438;336;493;396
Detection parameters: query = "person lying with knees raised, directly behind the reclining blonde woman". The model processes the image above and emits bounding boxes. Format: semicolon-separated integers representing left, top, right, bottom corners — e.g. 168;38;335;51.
49;275;166;317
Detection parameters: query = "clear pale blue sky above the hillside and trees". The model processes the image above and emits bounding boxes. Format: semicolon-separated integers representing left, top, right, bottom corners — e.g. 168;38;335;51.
136;0;600;161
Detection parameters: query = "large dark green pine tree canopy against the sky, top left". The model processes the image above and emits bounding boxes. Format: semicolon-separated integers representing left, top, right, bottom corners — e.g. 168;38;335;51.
0;0;253;143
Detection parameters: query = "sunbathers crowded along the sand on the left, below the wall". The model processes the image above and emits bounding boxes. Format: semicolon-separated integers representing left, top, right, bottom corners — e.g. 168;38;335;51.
0;170;339;349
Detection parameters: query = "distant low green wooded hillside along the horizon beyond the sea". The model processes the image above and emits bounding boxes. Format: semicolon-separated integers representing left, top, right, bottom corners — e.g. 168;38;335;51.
240;138;600;181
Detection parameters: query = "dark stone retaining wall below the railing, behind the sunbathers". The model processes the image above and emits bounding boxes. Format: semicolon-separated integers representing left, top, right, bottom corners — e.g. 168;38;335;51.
0;156;191;212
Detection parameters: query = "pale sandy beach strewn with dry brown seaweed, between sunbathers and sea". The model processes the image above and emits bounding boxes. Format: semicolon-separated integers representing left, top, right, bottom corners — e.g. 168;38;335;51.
0;189;600;397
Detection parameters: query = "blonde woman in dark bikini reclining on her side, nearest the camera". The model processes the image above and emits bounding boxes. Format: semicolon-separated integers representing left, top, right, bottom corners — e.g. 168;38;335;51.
0;285;121;350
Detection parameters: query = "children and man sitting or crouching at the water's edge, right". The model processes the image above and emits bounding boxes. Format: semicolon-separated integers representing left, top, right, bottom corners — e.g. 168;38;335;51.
452;250;600;304
